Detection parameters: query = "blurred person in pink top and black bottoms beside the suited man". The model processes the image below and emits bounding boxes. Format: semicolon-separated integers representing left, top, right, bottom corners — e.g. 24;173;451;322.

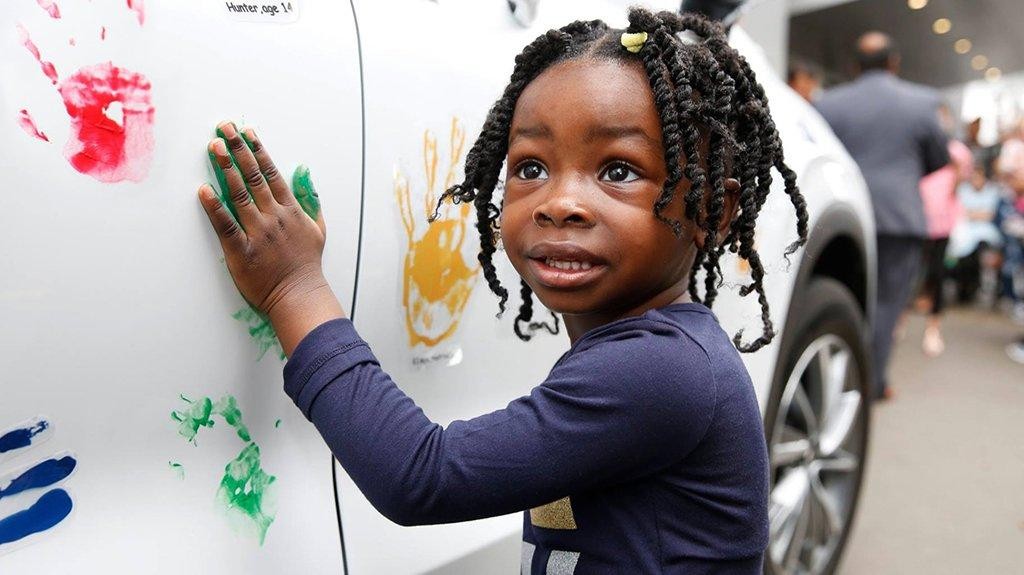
921;105;974;357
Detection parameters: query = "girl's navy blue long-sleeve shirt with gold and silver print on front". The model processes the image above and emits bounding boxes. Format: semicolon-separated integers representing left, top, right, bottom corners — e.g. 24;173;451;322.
285;304;768;575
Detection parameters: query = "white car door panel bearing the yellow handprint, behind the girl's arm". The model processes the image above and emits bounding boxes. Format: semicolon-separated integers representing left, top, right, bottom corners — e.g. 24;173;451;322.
339;0;625;574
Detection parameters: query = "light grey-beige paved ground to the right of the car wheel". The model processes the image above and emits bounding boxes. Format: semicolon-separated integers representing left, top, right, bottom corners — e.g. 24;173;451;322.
841;309;1024;575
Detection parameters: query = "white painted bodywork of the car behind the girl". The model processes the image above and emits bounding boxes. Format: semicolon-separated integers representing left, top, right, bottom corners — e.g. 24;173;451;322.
0;0;873;574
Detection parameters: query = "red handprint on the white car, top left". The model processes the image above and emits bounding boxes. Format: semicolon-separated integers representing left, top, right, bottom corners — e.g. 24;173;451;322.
17;0;156;183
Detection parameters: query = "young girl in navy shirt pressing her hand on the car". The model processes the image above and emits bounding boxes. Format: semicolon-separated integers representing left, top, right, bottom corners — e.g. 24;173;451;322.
200;8;807;574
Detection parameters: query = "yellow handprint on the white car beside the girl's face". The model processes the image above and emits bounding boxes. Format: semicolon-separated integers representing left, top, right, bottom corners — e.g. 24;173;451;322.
394;118;480;347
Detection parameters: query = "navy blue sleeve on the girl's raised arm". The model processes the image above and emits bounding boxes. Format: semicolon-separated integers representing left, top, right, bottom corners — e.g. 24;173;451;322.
285;319;718;525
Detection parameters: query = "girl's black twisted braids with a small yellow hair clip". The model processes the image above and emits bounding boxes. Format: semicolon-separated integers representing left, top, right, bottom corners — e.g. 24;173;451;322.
438;8;808;352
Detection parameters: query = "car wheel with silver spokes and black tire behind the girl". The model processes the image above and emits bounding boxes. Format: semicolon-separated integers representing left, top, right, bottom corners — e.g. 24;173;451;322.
765;277;870;575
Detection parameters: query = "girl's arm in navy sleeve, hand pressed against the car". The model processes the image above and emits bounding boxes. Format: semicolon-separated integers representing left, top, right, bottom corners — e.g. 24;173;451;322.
200;123;720;525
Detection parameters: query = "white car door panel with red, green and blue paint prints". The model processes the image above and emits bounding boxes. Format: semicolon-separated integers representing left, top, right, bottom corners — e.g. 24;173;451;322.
0;0;360;574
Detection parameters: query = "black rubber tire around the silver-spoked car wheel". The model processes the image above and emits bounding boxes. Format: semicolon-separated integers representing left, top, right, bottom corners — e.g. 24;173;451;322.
765;277;873;575
